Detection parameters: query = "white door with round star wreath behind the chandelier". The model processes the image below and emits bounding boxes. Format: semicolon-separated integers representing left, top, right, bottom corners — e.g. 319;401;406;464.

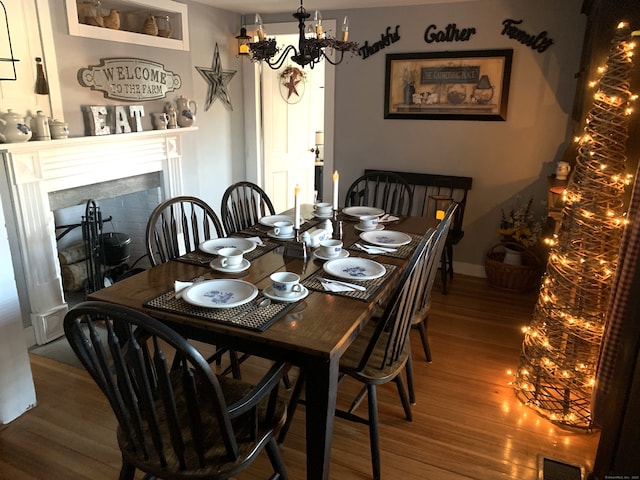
243;20;335;211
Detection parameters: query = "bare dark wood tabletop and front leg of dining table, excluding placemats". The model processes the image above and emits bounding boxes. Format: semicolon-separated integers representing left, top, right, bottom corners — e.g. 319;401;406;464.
88;205;435;479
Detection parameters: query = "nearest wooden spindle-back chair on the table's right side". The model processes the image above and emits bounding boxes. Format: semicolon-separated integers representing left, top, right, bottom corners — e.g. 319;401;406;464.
278;229;435;480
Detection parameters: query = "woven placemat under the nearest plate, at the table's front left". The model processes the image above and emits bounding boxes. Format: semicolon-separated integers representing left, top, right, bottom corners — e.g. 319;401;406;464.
144;290;296;332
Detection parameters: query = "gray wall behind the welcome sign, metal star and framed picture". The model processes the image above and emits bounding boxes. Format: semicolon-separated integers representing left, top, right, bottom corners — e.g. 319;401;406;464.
50;0;586;275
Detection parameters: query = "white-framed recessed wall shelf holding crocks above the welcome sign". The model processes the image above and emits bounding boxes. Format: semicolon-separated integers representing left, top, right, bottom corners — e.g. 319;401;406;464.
65;0;189;51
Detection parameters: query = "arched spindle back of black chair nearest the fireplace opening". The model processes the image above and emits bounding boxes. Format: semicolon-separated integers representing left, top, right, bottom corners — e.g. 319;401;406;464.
145;196;224;266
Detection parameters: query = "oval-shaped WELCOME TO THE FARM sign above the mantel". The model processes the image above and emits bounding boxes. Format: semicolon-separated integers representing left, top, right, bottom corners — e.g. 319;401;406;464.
78;58;182;102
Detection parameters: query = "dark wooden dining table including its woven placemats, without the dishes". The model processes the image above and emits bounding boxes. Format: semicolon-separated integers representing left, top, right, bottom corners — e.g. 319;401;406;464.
88;204;436;479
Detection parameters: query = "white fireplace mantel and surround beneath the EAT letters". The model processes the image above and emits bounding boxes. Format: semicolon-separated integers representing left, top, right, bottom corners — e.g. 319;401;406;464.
0;127;197;344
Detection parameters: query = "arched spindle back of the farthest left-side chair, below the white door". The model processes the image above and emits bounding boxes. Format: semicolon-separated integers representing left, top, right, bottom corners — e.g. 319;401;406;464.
220;182;276;235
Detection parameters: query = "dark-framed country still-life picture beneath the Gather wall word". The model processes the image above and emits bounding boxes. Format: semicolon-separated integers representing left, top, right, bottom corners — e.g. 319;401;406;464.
384;50;513;121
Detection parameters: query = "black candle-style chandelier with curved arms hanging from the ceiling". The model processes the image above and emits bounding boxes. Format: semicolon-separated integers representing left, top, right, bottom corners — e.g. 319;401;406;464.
236;0;358;70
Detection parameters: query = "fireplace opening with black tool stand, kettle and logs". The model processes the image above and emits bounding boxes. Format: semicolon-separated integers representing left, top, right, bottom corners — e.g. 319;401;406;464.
50;179;162;308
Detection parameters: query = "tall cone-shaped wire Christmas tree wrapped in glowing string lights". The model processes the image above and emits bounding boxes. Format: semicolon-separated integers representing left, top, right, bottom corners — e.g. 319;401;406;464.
513;24;634;429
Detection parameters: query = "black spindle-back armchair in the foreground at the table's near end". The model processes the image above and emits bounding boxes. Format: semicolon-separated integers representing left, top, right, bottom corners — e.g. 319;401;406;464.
64;301;287;480
